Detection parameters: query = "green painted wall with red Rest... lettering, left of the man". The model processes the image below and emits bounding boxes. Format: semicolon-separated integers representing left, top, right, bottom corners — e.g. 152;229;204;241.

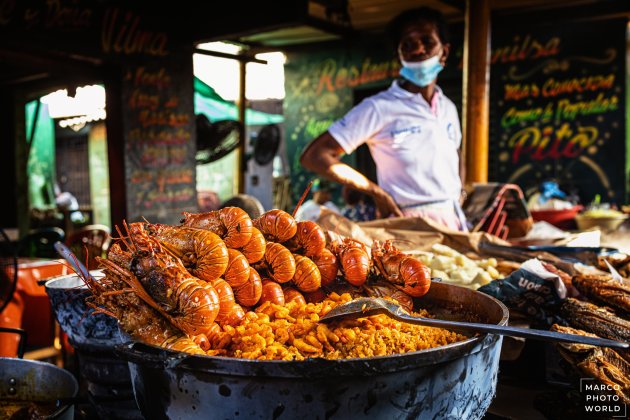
284;40;399;203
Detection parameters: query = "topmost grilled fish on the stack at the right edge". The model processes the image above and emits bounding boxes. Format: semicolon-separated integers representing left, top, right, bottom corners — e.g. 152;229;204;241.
573;275;630;317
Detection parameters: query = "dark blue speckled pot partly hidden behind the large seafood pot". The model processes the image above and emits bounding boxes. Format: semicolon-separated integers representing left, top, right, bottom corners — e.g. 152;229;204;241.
46;270;142;419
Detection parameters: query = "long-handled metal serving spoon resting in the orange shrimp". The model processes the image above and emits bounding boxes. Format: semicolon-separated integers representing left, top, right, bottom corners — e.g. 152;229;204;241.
320;298;629;349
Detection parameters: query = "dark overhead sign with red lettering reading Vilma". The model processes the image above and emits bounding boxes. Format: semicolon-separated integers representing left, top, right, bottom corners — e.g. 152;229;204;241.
0;0;178;58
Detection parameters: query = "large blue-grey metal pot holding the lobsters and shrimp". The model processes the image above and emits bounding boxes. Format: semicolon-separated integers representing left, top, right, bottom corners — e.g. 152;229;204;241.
119;283;508;419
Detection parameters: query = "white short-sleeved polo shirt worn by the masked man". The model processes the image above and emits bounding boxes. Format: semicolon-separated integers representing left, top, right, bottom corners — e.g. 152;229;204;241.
328;81;462;208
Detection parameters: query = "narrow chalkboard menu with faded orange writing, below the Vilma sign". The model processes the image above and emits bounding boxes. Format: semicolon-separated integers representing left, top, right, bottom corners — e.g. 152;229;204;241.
122;51;197;224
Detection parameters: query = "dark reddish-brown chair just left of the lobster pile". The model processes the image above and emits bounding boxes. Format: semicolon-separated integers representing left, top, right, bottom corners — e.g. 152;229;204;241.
66;225;111;270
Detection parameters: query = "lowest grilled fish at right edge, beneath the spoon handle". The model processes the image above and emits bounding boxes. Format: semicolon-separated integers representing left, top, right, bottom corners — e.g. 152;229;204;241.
551;324;630;404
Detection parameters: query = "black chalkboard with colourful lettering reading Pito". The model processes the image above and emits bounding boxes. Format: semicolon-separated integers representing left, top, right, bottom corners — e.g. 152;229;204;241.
490;19;627;204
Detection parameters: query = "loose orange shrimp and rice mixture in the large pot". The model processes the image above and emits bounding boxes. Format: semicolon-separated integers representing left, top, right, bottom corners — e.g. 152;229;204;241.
212;293;467;360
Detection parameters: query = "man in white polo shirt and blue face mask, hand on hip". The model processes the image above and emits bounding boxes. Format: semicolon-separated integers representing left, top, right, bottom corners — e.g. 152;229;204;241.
300;7;466;230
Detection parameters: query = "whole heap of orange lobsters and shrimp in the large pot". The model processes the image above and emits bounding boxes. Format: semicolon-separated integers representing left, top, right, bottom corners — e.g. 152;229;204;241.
84;207;464;360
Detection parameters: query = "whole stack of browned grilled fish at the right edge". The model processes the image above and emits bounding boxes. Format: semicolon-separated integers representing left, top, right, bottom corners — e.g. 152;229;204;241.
552;274;630;404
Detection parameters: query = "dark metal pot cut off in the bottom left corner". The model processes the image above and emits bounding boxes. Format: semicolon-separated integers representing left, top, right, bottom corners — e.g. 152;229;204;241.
0;357;79;420
